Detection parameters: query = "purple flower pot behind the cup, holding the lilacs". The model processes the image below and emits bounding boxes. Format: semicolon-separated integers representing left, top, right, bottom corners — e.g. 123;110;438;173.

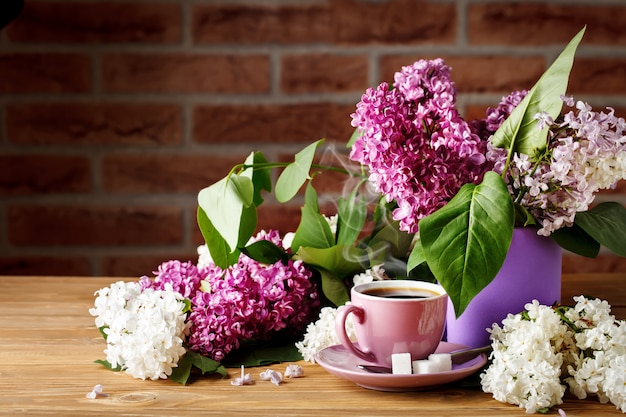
446;228;563;347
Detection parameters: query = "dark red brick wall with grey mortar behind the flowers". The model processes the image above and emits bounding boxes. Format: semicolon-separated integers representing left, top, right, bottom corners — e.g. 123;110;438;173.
0;0;626;276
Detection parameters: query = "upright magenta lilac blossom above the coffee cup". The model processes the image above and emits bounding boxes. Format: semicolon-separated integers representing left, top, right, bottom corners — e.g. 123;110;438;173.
350;59;488;232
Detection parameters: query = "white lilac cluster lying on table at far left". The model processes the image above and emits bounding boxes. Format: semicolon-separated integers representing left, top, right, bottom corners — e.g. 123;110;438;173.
90;282;188;380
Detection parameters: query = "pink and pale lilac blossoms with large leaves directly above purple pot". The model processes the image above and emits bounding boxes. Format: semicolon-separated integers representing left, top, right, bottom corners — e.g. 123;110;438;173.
350;27;626;316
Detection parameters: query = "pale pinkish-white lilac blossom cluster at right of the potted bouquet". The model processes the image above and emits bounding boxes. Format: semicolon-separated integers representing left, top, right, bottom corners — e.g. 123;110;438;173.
487;97;626;236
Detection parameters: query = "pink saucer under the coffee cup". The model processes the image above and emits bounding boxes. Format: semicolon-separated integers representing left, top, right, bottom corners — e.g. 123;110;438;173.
315;342;487;391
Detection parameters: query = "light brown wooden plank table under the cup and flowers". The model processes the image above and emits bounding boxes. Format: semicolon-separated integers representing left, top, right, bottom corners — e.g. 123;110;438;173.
0;273;626;417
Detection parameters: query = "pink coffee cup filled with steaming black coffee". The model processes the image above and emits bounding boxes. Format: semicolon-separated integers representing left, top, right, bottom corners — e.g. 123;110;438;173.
335;280;448;366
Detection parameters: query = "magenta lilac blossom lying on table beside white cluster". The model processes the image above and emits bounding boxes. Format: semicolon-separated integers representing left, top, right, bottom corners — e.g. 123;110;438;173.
188;231;319;361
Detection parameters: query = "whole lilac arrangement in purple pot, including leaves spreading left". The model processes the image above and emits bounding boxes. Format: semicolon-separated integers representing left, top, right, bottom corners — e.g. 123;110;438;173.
198;29;626;316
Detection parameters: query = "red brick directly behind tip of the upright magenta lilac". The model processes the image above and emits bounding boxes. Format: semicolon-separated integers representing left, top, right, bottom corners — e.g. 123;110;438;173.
381;55;546;93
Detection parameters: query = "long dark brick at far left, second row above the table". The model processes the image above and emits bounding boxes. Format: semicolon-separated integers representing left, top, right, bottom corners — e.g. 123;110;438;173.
7;204;183;246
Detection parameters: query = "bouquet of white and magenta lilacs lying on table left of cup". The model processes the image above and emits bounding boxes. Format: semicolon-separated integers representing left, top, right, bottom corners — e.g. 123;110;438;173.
90;231;319;384
